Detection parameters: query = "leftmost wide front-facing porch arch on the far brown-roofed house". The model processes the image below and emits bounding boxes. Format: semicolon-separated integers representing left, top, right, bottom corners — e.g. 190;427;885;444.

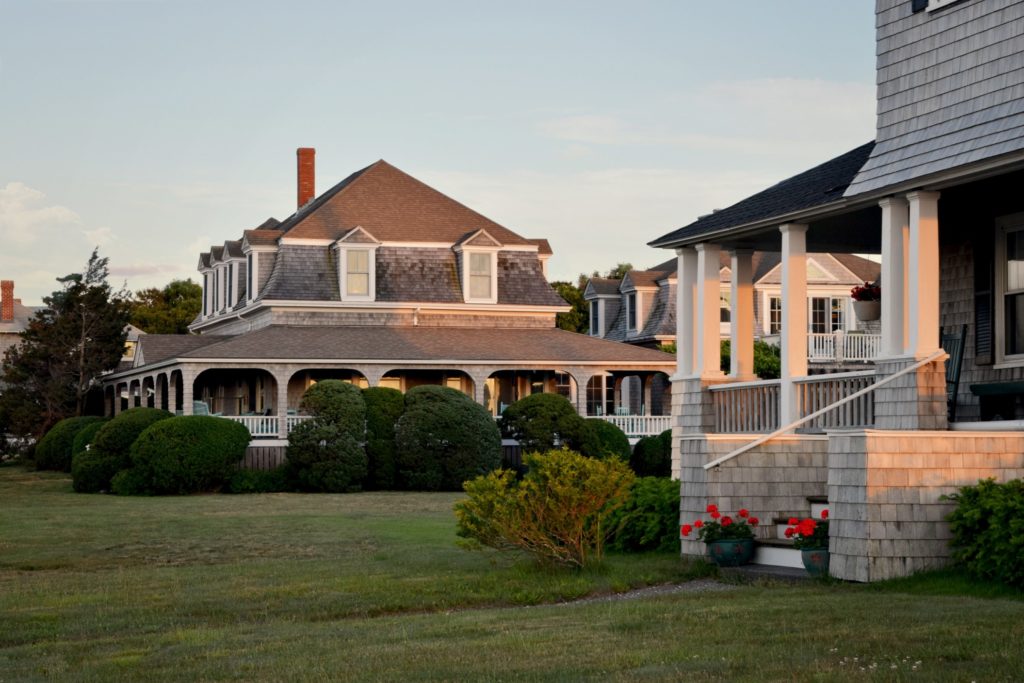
192;368;278;416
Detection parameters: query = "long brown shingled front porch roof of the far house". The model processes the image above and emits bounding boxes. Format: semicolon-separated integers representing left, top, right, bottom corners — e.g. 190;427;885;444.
172;326;676;369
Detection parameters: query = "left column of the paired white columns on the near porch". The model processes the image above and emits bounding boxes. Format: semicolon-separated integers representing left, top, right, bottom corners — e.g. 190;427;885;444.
879;197;909;358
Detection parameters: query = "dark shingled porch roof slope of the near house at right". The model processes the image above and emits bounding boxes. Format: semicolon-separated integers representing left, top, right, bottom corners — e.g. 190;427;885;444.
648;141;874;247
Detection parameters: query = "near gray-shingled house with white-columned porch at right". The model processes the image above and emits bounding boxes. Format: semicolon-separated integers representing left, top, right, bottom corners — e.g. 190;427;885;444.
651;0;1024;581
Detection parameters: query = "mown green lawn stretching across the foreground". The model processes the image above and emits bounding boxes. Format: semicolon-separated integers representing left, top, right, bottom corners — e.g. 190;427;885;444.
0;467;1024;681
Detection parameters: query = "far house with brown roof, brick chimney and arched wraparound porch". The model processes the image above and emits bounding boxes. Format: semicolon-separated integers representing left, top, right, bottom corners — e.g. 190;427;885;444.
106;148;674;446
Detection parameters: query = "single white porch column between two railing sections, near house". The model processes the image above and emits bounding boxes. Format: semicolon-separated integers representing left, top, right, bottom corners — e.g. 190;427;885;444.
778;223;807;426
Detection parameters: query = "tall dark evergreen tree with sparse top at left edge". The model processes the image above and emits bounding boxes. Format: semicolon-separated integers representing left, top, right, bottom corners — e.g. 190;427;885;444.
0;250;129;436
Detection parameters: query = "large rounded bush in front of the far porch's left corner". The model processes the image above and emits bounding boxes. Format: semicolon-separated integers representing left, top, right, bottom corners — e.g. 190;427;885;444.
114;415;251;494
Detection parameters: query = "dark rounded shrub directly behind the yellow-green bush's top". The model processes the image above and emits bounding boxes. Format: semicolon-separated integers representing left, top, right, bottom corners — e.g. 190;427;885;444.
502;393;586;453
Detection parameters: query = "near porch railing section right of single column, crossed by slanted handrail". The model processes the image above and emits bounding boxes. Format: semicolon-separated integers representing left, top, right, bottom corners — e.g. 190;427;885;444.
794;371;876;429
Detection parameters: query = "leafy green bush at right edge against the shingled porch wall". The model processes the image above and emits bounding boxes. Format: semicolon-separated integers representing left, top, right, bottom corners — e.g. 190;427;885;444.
946;479;1024;588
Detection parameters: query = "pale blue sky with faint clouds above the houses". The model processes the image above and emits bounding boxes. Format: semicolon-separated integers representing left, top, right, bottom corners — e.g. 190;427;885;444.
0;0;874;305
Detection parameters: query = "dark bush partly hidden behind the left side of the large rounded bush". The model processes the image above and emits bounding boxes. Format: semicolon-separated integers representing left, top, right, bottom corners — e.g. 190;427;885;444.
71;408;174;494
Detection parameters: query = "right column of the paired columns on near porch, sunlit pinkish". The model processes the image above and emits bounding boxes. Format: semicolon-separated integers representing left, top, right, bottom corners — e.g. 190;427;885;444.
906;191;939;358
